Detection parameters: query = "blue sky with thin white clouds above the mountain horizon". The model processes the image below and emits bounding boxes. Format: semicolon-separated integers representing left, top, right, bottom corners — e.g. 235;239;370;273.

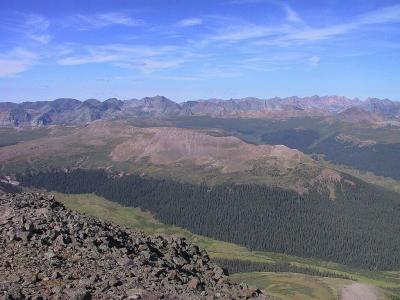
0;0;400;102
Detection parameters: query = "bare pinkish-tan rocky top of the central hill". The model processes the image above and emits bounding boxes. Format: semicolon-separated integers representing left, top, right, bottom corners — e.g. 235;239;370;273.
111;128;312;174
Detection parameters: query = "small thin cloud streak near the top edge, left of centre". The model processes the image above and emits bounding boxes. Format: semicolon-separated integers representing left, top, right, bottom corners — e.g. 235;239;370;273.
69;12;143;30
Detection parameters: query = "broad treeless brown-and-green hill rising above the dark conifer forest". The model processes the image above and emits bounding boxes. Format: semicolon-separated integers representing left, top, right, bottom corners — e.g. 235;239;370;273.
0;120;324;191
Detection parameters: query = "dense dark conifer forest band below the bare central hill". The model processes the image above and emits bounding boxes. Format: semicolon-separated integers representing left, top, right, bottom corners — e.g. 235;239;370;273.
18;170;400;269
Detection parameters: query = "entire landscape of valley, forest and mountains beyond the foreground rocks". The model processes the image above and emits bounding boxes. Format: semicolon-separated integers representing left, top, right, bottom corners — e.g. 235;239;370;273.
0;96;400;300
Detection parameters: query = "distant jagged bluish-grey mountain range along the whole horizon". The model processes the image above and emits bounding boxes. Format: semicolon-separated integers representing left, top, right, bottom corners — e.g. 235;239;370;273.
0;96;400;127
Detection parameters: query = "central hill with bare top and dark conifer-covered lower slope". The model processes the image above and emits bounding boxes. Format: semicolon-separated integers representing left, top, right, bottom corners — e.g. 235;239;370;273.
0;119;399;269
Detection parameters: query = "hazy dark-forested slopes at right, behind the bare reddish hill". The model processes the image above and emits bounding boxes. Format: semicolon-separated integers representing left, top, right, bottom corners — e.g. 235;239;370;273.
168;115;400;180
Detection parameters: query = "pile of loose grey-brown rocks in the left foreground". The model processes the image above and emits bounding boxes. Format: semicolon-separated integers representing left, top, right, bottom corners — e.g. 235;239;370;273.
0;193;266;300
